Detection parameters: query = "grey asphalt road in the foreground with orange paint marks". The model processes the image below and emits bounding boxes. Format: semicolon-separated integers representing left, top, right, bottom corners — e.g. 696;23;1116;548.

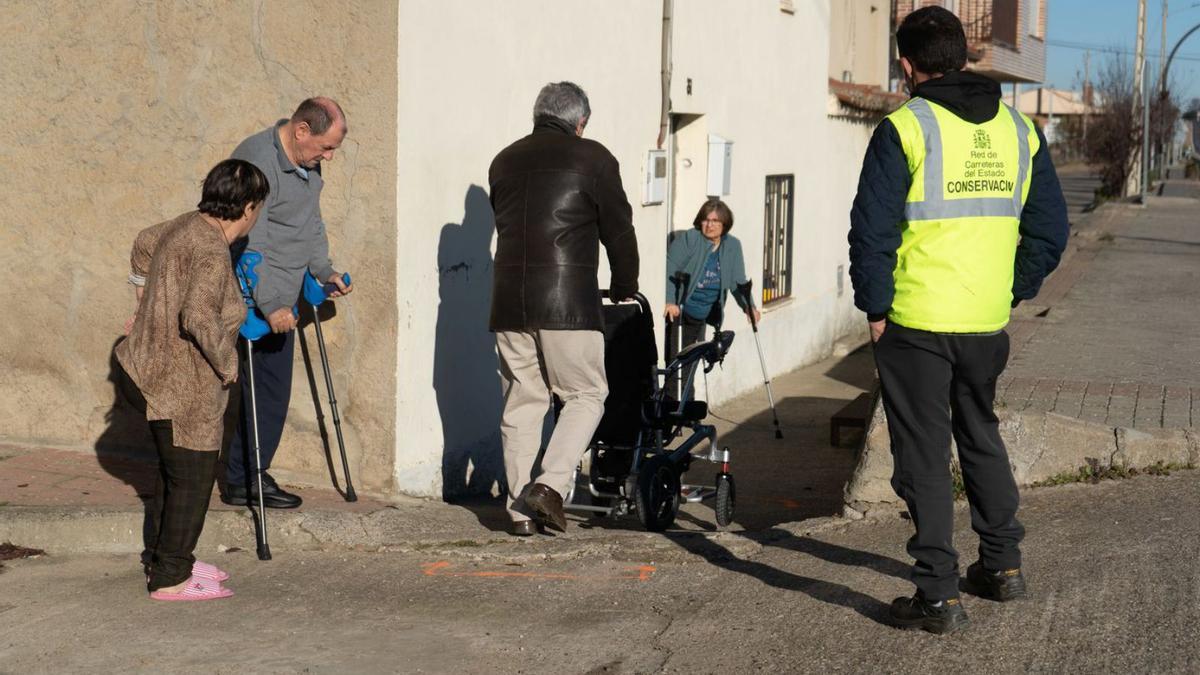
0;471;1200;673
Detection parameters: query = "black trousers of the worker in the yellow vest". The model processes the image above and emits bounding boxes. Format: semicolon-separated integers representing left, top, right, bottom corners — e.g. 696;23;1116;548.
875;322;1025;601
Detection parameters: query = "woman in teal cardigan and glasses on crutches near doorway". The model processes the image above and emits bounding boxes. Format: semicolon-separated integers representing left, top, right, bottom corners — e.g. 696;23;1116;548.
664;194;762;389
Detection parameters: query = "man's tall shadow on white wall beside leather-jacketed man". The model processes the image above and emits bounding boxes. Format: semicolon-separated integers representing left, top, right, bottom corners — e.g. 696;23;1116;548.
433;185;504;498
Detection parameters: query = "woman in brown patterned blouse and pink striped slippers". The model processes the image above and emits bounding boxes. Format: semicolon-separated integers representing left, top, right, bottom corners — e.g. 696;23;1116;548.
116;160;270;601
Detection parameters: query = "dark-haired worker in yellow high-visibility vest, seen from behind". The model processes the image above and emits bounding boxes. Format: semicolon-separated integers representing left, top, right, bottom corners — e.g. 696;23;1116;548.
850;6;1068;633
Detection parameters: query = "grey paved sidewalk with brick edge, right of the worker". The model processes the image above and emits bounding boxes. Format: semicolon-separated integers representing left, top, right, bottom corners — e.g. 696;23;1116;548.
997;181;1200;430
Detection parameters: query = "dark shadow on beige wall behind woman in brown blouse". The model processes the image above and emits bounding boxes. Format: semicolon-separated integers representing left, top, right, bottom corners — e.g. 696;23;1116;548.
95;336;158;501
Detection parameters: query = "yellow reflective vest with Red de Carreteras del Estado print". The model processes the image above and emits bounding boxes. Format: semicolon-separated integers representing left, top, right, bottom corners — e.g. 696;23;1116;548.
888;98;1038;333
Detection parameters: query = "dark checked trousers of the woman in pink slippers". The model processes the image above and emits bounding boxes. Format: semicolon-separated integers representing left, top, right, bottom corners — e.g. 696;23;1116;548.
142;419;218;591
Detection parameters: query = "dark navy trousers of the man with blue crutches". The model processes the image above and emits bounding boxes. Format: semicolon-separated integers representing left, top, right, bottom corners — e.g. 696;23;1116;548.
226;330;295;486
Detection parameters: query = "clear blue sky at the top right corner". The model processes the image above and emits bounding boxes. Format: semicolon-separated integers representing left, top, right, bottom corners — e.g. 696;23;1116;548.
1045;0;1200;104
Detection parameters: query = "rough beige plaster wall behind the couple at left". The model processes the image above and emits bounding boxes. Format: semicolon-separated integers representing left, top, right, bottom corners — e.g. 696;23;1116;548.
0;0;396;489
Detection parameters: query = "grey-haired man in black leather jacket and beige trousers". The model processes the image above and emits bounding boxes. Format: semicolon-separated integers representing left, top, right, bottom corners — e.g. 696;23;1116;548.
488;82;638;536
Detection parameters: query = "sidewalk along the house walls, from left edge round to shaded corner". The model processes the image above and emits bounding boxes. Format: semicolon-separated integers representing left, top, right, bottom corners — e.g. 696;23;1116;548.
0;329;874;554
